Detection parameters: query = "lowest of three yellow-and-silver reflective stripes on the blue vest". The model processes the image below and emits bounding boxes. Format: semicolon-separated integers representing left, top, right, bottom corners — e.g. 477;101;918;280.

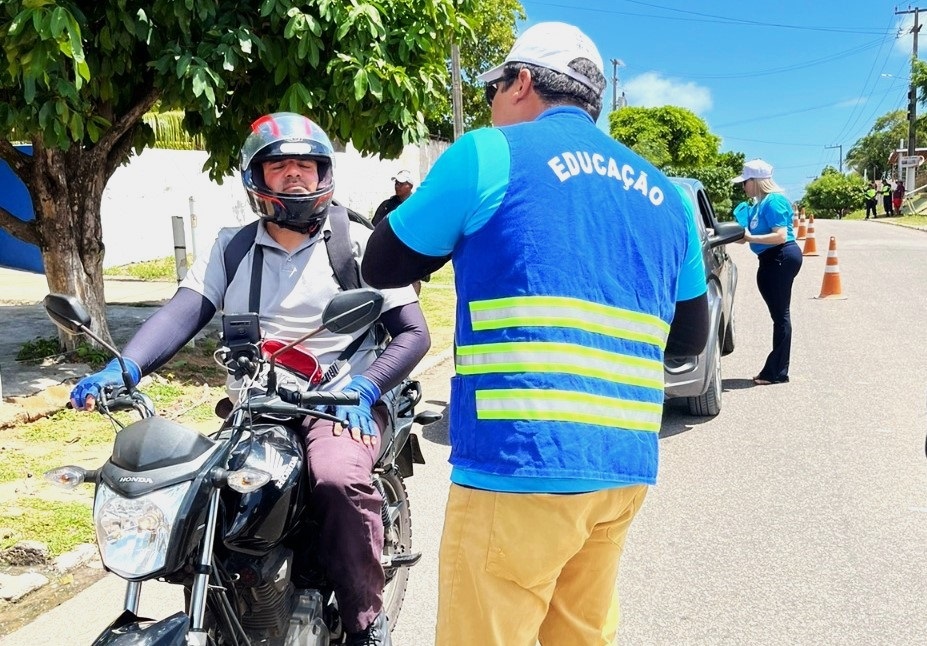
476;388;663;433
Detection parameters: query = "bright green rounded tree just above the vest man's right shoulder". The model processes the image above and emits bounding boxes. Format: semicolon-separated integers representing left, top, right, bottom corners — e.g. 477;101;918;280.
608;106;744;219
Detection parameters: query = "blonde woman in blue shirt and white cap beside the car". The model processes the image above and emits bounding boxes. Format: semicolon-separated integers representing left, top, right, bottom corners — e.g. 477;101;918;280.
731;159;802;386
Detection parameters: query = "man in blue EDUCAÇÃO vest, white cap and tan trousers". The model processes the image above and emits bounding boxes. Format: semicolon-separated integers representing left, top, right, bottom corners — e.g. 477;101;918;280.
362;23;708;646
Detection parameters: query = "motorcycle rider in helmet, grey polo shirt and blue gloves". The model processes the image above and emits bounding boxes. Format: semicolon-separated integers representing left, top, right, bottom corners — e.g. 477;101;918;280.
71;112;431;645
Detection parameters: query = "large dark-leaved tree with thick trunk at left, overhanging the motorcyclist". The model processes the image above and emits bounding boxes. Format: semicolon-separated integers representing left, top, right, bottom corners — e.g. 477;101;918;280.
0;0;472;345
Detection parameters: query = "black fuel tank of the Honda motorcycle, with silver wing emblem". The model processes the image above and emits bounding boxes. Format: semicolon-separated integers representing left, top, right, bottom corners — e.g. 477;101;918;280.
222;425;305;554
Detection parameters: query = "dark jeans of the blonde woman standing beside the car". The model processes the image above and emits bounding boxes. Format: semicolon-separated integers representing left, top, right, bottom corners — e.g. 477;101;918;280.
756;242;802;381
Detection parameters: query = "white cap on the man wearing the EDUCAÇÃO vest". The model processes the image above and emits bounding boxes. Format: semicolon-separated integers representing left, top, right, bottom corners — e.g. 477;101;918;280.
477;22;605;92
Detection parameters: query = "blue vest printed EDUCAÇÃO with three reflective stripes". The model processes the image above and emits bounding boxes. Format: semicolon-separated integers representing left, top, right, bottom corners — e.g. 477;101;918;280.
450;110;688;492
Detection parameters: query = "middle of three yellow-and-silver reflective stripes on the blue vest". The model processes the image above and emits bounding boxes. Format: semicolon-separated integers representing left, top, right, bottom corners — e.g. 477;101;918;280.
456;341;663;391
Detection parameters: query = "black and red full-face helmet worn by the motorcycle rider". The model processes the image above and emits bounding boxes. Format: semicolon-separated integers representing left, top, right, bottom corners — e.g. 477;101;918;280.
241;112;335;233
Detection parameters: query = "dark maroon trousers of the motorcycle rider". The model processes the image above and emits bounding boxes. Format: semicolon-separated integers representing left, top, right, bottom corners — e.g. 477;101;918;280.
306;406;387;632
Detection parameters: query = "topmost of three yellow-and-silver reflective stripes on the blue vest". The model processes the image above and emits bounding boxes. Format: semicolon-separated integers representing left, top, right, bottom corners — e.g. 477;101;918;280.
470;296;669;350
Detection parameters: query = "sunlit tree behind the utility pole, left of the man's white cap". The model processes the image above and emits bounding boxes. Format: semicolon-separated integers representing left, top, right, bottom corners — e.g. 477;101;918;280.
425;0;525;140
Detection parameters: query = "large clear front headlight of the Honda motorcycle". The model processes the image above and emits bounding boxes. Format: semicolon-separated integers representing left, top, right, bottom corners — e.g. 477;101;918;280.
93;482;190;579
